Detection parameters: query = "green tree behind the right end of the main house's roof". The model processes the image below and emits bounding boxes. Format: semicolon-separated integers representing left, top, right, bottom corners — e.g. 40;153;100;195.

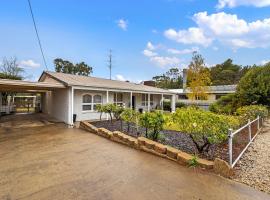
152;67;183;89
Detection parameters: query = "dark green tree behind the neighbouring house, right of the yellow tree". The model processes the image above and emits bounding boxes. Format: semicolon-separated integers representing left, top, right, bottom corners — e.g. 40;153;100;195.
210;59;249;85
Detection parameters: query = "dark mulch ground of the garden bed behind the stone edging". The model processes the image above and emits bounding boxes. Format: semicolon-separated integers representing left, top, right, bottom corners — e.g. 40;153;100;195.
91;120;228;161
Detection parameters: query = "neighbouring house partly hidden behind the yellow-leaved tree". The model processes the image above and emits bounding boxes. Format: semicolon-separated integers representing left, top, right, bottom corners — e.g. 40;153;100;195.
169;85;237;108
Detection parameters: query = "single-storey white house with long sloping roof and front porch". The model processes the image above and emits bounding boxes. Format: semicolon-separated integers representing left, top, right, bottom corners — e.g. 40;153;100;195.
32;71;175;125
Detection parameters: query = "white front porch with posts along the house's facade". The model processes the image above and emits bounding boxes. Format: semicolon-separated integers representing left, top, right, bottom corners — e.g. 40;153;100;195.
73;87;175;121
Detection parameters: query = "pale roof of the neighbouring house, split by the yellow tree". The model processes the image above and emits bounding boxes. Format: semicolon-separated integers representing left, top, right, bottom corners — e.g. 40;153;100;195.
170;85;237;94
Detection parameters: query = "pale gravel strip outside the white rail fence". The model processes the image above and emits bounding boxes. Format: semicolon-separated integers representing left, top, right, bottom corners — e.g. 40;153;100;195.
234;120;270;193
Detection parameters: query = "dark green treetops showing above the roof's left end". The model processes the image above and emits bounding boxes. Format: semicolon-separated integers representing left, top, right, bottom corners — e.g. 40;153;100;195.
54;58;93;76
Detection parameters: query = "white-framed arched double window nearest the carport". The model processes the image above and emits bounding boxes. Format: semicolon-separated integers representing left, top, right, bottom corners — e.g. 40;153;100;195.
82;94;102;112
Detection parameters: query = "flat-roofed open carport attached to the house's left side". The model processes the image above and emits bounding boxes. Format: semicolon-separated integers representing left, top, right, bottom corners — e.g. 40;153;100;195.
0;79;66;120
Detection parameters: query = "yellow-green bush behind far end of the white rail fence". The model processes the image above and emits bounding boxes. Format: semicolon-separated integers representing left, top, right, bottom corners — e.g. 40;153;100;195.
236;105;268;124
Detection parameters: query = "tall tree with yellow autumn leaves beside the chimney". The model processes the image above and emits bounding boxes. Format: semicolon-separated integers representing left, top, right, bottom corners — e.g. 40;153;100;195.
187;52;211;100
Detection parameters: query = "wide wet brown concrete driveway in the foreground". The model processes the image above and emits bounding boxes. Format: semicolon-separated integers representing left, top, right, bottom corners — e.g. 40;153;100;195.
0;115;270;200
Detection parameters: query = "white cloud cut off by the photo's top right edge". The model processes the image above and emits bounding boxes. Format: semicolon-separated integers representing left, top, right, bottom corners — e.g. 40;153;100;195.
217;0;270;9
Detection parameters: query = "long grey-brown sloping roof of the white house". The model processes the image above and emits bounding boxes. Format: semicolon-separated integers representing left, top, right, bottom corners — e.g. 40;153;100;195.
40;71;173;94
